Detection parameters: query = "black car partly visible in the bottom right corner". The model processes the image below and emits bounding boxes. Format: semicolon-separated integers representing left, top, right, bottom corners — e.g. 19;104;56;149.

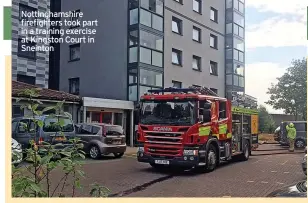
267;180;307;198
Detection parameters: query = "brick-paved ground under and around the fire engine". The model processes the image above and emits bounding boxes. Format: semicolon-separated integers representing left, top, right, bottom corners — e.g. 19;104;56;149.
41;144;306;197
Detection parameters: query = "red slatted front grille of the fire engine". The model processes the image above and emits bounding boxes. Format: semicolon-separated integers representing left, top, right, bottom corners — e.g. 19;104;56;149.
145;132;183;157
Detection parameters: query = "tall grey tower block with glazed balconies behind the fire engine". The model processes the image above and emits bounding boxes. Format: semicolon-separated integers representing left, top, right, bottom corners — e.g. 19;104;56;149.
56;0;244;146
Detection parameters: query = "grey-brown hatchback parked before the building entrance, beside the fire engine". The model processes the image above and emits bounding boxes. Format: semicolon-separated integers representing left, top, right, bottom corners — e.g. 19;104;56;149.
76;123;126;159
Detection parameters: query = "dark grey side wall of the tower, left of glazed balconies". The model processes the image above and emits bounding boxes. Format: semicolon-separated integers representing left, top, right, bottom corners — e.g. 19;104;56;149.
60;0;128;100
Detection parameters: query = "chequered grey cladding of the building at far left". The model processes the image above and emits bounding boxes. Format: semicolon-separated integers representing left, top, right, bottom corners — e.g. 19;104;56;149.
12;0;50;88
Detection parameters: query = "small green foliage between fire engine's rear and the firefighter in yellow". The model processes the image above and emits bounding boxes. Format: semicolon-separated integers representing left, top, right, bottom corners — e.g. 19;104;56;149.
258;105;275;133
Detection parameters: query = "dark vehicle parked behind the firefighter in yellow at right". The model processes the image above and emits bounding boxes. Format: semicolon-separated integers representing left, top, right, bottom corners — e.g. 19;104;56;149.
279;121;307;148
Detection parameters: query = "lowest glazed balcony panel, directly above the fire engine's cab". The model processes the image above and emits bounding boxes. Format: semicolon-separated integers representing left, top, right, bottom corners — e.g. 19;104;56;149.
140;69;163;87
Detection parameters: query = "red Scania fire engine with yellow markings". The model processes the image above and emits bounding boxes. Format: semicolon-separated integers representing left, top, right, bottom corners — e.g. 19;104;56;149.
137;87;258;172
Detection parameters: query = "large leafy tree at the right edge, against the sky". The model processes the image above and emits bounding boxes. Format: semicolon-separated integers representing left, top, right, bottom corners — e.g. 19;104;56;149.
266;58;307;120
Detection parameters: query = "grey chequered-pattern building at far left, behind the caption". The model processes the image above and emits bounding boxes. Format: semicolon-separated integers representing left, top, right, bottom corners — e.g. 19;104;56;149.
12;0;50;88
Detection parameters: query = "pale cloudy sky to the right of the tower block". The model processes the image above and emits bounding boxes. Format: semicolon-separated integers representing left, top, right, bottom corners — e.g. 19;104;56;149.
245;0;308;113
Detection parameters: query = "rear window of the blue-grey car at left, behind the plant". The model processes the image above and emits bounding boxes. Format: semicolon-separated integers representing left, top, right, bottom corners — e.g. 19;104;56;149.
43;116;74;132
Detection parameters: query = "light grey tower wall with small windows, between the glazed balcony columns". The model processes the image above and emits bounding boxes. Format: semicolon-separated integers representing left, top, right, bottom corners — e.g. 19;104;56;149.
164;0;225;96
